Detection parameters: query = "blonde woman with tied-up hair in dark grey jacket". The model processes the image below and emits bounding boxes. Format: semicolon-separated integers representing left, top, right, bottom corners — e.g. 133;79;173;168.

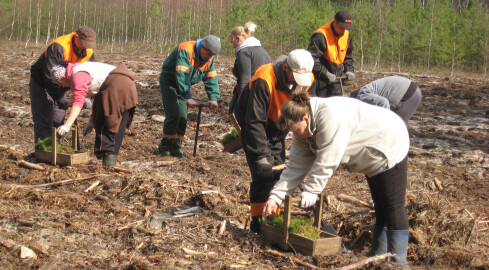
228;22;272;114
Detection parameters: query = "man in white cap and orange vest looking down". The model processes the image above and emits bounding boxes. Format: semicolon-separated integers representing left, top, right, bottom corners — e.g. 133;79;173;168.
234;49;314;232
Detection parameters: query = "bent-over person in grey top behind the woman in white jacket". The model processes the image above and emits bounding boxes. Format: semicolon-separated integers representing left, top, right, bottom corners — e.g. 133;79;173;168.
350;76;422;126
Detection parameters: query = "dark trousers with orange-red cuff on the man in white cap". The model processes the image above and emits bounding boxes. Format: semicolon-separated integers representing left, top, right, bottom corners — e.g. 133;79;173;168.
243;137;285;217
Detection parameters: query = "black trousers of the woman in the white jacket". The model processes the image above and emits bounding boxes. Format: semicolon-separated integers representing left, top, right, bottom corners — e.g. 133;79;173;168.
367;156;409;230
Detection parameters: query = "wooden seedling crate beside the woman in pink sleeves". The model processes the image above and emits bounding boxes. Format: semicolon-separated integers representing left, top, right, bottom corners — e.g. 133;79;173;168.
34;125;88;166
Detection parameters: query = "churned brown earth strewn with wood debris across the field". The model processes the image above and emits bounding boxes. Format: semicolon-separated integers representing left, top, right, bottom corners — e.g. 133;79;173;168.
0;44;489;269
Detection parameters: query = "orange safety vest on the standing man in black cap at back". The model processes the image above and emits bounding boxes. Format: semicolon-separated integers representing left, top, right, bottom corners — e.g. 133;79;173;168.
315;21;350;64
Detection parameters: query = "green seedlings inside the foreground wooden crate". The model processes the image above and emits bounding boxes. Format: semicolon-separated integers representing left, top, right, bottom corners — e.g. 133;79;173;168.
265;215;321;240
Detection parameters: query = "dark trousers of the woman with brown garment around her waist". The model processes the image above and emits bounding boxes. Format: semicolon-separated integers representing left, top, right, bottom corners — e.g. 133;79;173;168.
93;108;134;159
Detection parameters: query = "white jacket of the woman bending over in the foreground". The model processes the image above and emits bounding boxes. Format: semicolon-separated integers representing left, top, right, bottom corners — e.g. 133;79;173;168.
270;97;409;204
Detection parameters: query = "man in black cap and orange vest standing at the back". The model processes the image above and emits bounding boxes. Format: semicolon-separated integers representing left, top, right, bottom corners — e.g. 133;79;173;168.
307;10;355;97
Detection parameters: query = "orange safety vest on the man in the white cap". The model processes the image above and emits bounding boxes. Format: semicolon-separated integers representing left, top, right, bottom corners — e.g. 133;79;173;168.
249;63;314;123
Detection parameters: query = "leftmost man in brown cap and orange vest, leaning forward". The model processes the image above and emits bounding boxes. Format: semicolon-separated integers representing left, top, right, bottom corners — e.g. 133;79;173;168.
29;26;95;143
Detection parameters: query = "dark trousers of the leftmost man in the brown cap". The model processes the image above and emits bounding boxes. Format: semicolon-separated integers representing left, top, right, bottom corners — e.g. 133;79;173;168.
29;79;66;143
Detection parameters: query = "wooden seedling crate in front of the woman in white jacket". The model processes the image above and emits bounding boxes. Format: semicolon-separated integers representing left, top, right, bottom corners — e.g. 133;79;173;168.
261;195;341;256
